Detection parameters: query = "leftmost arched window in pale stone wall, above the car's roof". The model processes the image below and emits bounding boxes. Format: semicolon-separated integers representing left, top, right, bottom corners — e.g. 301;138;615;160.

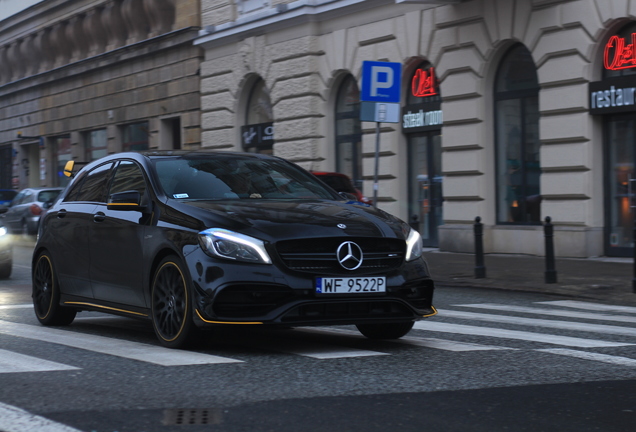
241;79;274;154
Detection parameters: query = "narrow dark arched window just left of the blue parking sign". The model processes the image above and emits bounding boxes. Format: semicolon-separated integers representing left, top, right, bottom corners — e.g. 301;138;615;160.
336;75;362;190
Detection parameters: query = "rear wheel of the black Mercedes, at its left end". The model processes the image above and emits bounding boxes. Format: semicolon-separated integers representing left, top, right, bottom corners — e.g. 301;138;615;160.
32;251;77;326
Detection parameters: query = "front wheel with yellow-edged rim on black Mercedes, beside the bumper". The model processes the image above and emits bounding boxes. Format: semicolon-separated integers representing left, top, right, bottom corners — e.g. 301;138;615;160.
151;256;198;348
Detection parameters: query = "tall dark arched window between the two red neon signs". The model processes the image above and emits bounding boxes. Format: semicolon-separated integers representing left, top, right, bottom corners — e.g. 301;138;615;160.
494;44;541;224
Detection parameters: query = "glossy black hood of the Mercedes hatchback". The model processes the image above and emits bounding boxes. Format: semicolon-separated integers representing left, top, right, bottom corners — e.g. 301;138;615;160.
171;199;405;241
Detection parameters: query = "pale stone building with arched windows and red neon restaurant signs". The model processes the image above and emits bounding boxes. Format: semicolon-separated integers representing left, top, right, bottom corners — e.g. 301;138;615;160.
195;0;636;257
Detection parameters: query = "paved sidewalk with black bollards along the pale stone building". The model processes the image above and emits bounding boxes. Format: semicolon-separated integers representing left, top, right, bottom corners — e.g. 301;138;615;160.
424;249;636;306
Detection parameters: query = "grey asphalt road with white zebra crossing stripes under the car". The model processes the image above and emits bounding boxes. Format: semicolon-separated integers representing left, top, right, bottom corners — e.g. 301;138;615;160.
0;241;636;432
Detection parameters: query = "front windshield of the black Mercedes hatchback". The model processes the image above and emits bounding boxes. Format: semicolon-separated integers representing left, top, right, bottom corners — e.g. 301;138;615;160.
153;155;338;200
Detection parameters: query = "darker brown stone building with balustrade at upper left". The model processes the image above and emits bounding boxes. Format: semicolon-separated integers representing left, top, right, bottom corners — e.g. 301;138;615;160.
0;0;202;189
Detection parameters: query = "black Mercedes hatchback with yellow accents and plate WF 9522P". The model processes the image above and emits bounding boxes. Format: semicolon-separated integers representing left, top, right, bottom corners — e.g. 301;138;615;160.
33;151;436;347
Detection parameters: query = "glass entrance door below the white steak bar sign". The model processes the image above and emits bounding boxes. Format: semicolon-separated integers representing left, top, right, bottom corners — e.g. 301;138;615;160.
408;131;444;247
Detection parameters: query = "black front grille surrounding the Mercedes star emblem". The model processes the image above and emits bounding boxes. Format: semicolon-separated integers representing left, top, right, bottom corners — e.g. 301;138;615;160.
276;237;406;275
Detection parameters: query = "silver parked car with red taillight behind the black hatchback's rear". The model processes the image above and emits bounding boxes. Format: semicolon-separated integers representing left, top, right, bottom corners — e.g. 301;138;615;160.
4;188;63;235
